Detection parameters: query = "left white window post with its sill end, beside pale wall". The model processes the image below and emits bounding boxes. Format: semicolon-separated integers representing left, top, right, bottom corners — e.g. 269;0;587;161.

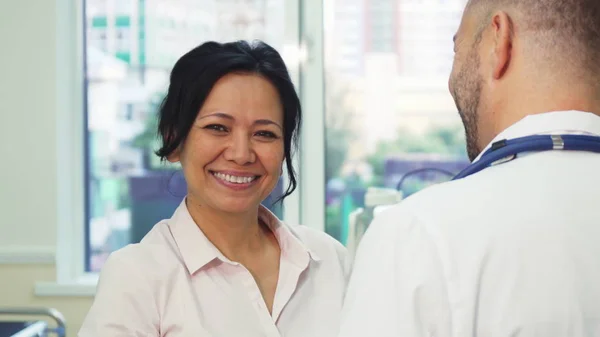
35;0;95;296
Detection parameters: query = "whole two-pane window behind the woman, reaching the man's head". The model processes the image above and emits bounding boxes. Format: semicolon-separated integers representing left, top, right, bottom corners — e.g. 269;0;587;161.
83;0;468;272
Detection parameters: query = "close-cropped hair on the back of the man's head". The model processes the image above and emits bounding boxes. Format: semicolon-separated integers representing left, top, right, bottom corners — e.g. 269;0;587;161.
467;0;600;82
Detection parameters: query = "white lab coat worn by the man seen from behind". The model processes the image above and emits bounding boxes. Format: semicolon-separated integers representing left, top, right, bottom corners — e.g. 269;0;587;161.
339;111;600;337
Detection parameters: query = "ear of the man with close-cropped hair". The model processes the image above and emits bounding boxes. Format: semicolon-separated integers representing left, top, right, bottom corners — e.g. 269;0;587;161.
491;11;513;80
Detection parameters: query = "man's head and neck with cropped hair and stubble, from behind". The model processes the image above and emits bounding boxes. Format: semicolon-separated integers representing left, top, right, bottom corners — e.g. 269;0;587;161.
449;0;600;159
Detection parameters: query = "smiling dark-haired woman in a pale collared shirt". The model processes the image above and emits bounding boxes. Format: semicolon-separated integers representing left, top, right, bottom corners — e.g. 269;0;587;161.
80;41;349;337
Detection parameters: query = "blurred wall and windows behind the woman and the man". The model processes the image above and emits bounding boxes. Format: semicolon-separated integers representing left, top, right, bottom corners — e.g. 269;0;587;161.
0;0;468;335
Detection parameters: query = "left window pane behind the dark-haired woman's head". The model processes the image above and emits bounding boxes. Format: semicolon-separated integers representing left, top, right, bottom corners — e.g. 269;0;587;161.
85;0;289;271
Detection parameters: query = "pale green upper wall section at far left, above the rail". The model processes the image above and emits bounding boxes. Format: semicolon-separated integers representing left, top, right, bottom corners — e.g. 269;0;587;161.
0;0;57;247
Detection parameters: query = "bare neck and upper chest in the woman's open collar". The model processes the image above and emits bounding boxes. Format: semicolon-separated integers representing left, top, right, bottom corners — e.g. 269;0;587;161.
186;198;269;263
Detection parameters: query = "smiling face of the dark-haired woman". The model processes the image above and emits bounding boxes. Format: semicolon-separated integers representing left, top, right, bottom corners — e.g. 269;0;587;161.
169;74;284;213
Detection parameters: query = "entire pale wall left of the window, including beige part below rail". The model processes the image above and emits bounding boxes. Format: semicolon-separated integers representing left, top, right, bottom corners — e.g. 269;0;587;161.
0;0;91;336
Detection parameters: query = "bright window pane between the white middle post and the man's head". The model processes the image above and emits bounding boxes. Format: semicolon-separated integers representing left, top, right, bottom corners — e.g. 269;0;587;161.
325;0;468;251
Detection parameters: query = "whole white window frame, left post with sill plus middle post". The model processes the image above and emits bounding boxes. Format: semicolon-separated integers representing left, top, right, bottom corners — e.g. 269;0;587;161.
35;0;325;296
